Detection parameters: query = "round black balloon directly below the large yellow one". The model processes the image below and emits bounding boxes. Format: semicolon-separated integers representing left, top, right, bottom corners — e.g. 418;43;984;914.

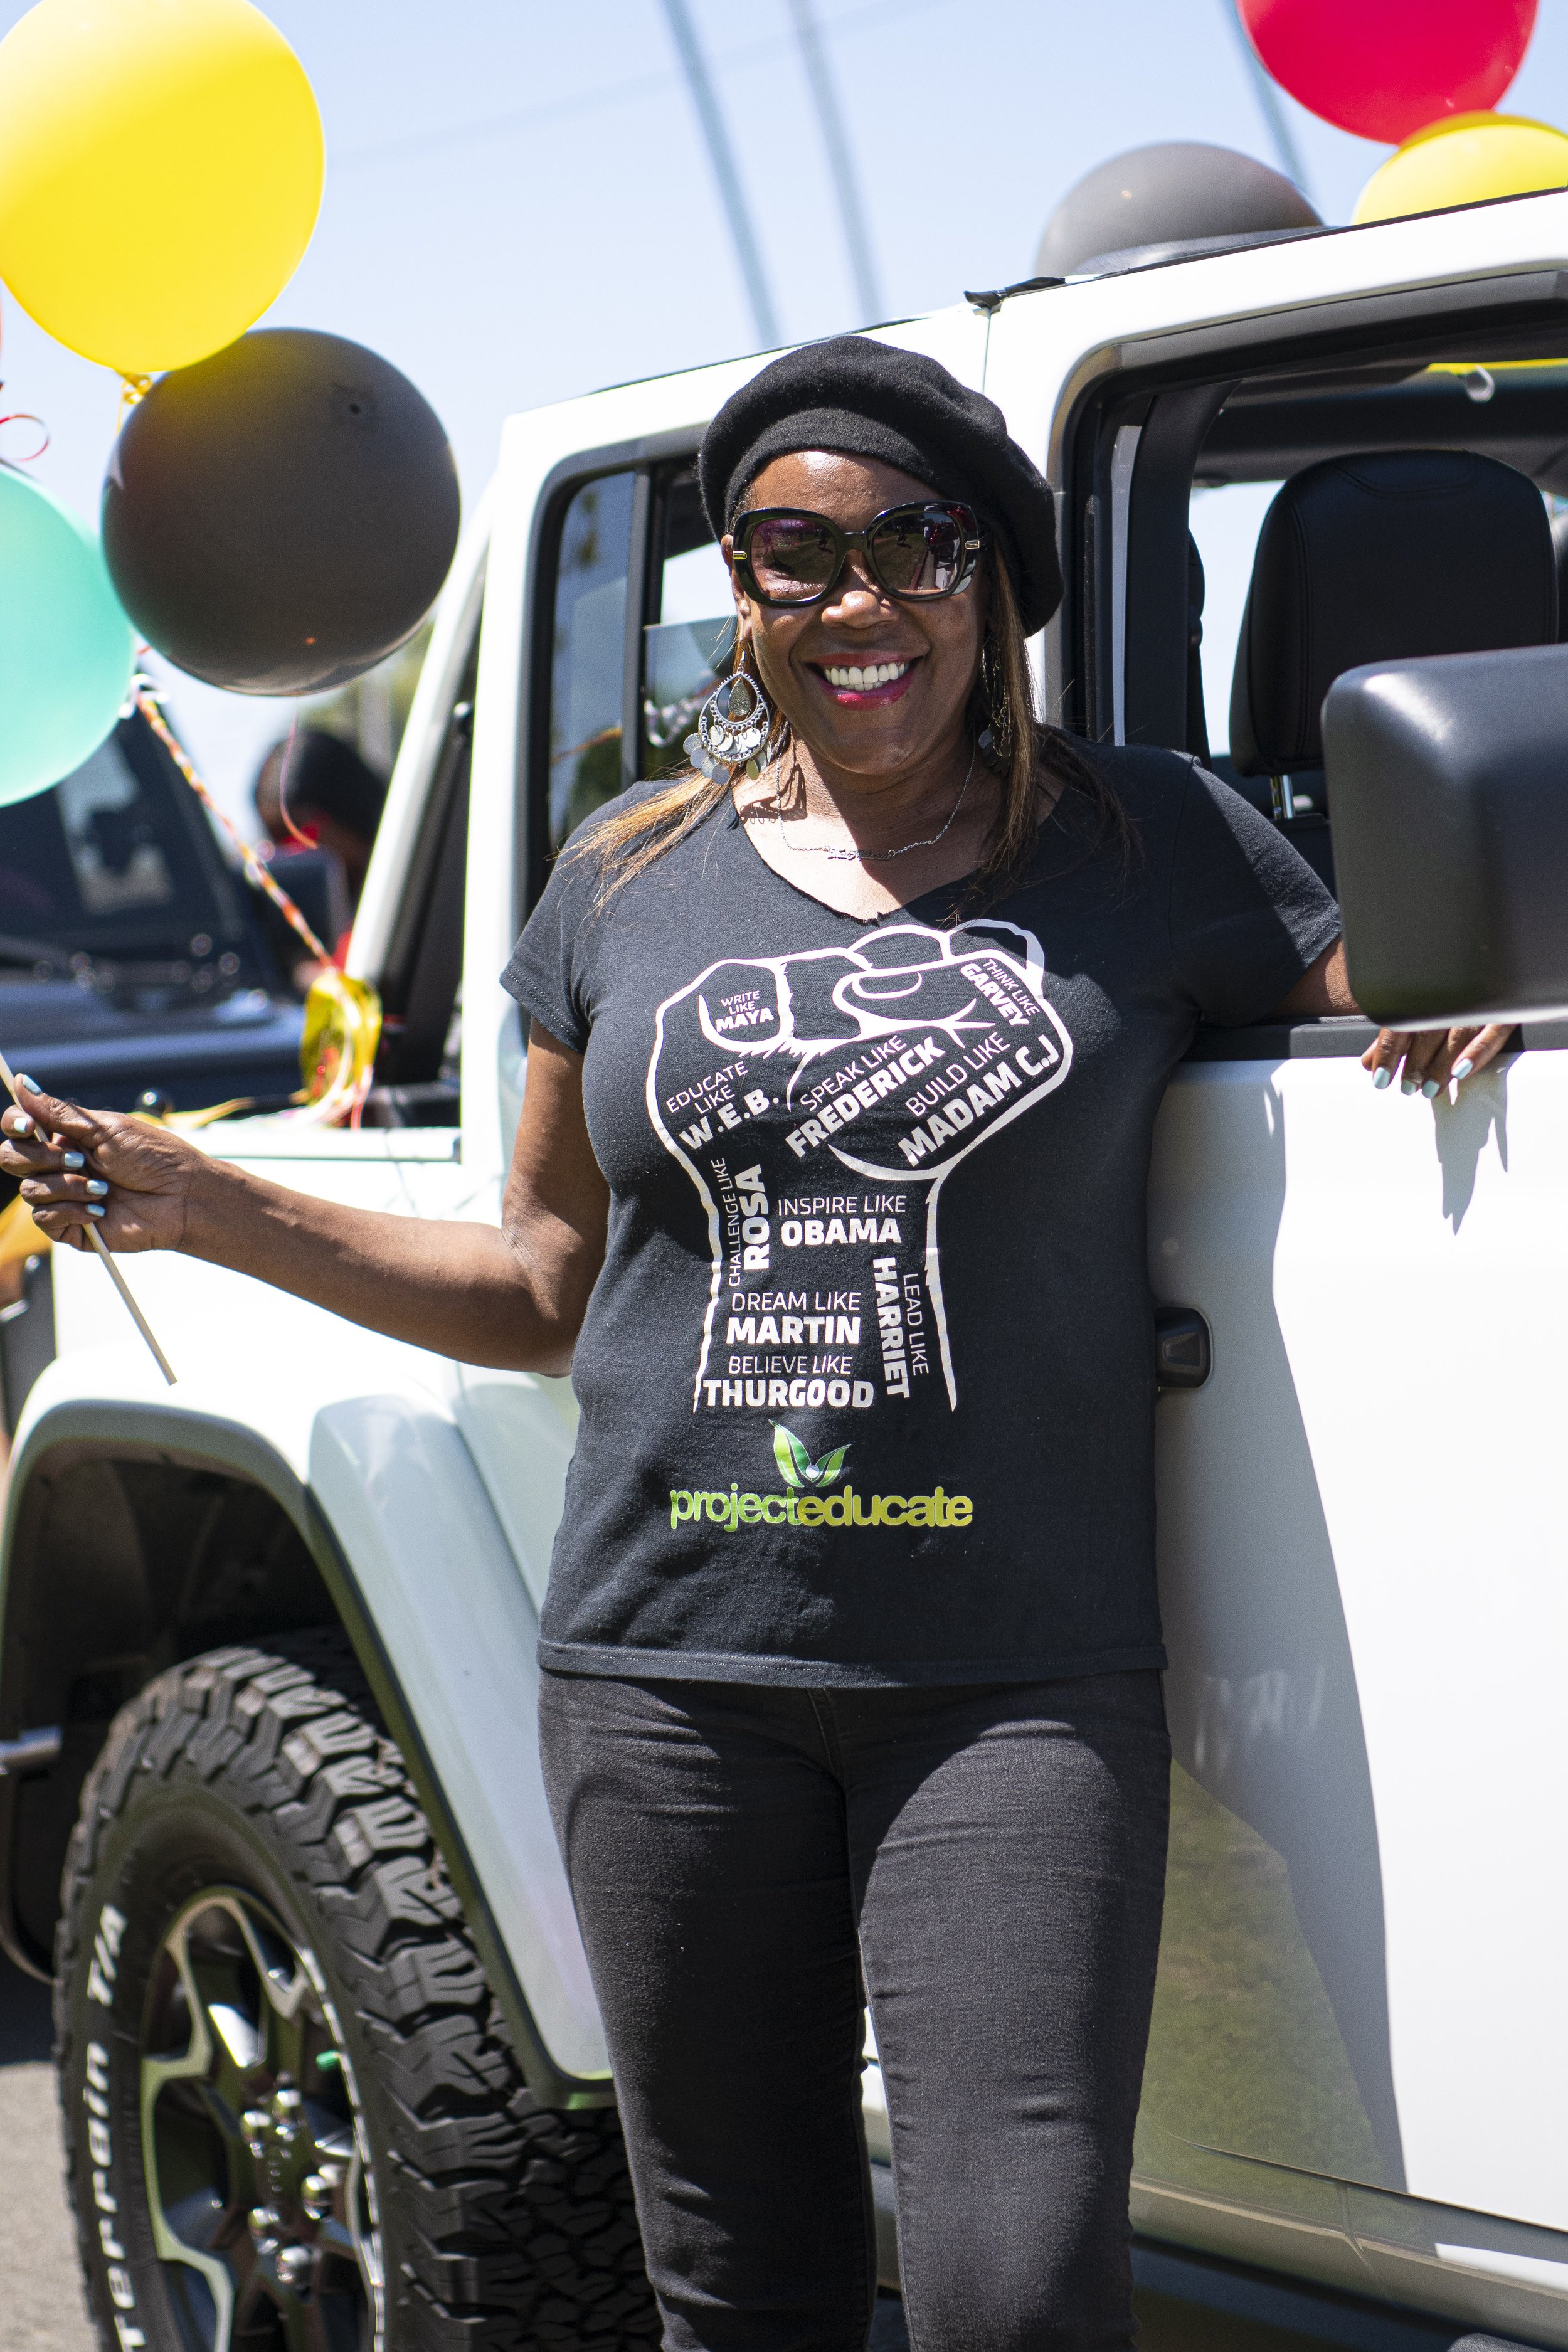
103;327;458;694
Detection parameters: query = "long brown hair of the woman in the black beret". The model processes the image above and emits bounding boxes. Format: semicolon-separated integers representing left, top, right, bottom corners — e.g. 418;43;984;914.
569;553;1133;906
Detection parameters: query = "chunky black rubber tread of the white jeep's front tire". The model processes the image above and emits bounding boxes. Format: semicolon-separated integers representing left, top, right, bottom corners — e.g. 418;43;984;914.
54;1633;658;2352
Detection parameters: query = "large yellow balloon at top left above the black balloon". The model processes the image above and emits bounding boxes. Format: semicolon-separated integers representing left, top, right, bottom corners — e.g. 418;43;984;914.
0;0;327;376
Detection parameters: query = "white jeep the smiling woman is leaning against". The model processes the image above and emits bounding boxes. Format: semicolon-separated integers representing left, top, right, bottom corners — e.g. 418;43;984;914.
12;179;1568;2352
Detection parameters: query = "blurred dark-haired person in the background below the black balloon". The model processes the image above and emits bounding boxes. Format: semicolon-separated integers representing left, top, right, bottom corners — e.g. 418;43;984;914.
252;727;386;995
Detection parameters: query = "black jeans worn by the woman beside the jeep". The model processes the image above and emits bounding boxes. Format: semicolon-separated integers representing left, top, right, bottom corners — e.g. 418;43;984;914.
541;1672;1171;2352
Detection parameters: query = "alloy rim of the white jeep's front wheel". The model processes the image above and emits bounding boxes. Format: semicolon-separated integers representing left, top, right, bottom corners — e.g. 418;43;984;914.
141;1887;386;2352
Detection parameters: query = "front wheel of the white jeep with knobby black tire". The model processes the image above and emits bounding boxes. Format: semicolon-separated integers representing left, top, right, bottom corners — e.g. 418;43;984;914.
54;1633;658;2352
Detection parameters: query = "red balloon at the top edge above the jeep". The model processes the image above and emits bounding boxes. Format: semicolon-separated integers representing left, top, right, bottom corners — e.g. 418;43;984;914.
1237;0;1535;144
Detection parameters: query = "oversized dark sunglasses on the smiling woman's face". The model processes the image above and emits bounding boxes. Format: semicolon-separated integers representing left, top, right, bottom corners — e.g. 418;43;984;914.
733;499;985;605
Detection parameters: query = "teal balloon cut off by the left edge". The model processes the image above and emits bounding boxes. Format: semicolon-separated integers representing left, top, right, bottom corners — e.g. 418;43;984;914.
0;466;136;807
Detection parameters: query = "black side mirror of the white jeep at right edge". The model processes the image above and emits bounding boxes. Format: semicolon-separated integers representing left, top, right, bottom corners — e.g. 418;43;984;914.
1323;645;1568;1028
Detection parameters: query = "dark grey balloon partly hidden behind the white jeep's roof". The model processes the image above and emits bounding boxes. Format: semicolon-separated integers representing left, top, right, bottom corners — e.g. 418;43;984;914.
1034;139;1321;278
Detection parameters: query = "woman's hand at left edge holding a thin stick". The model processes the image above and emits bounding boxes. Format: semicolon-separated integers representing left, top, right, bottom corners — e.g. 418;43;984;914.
0;1075;207;1251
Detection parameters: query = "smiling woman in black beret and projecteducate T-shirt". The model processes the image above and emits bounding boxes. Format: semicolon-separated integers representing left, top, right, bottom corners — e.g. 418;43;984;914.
0;339;1502;2352
